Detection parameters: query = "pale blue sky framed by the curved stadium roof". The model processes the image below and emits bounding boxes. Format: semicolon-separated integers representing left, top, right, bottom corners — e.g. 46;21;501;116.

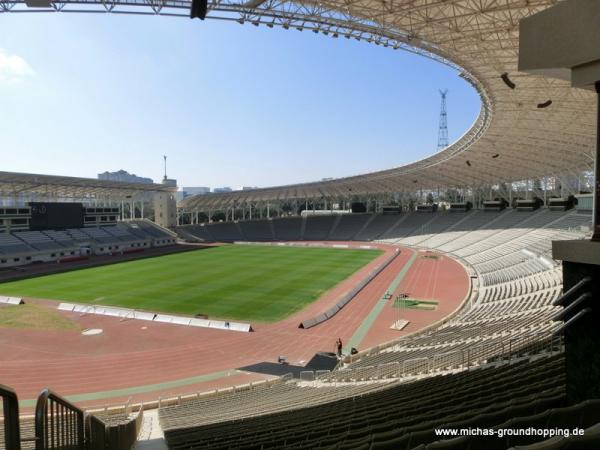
0;14;479;187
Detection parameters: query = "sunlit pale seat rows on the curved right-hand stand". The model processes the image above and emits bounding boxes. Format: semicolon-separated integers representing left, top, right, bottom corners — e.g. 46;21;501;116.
328;210;590;380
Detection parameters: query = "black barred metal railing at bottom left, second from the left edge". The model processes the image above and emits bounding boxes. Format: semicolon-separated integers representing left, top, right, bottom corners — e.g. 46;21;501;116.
35;389;85;450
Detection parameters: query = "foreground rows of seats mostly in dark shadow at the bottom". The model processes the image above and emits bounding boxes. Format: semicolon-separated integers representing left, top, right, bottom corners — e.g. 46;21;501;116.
159;355;580;450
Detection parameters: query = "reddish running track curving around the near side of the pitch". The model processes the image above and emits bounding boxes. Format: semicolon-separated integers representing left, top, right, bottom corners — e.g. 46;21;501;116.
0;244;469;408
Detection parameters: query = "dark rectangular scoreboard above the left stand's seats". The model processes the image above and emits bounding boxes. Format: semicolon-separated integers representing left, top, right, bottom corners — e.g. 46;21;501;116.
29;202;84;231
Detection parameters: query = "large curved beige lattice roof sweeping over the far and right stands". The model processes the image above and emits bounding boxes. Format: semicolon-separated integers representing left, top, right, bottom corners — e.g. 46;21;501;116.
0;0;595;209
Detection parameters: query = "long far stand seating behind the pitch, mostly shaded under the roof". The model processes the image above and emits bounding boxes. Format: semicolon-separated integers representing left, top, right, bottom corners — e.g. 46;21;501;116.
178;209;591;250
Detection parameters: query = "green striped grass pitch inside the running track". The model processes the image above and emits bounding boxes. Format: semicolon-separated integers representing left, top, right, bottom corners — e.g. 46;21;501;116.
0;245;381;322
